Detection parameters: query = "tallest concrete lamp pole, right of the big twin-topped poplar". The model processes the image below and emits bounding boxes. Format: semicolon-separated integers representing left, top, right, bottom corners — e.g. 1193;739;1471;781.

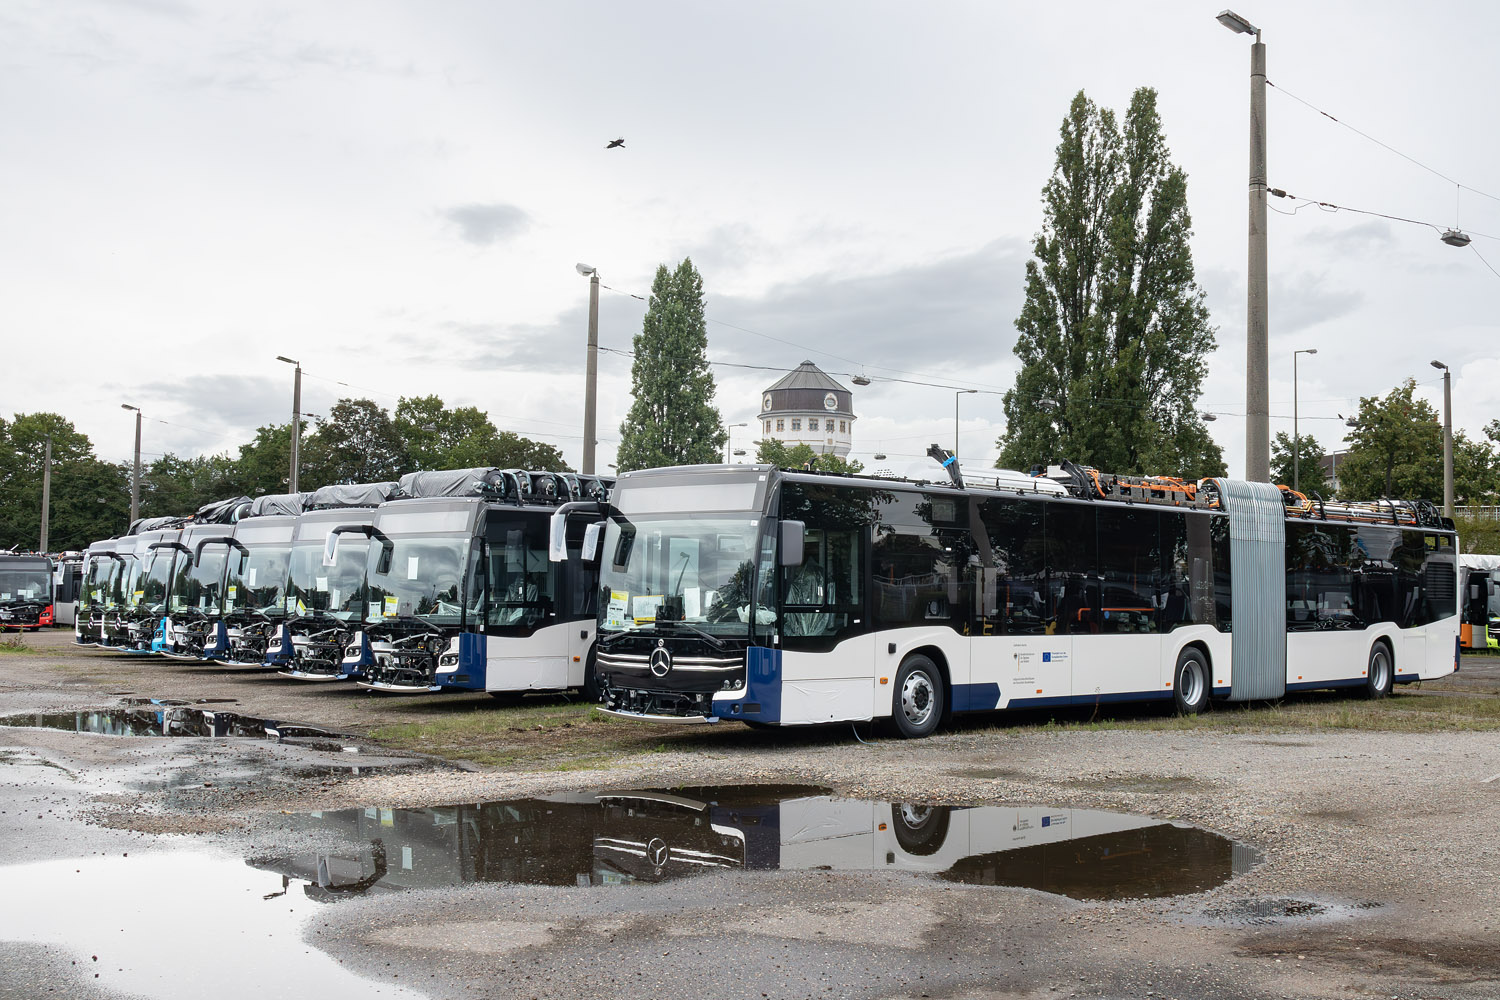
1218;10;1271;483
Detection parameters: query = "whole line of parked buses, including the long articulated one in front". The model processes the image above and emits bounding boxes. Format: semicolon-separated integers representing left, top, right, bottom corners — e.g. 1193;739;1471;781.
61;447;1494;736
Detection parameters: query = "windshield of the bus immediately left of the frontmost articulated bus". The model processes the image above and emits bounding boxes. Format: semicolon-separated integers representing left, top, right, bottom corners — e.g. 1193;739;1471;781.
368;535;470;625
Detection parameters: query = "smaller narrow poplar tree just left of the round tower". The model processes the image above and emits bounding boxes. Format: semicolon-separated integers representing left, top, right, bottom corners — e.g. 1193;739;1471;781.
618;258;726;472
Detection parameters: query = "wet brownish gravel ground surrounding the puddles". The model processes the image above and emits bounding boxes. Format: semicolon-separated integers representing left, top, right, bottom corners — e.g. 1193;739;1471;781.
0;636;1500;1000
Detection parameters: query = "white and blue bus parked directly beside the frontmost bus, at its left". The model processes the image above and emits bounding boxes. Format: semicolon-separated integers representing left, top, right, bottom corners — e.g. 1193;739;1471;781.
348;468;611;700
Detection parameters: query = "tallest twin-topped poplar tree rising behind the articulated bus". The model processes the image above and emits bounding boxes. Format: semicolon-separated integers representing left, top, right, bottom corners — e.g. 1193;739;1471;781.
998;87;1224;478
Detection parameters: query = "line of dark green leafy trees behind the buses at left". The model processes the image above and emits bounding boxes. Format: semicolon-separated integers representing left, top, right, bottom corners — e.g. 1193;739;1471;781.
0;396;567;552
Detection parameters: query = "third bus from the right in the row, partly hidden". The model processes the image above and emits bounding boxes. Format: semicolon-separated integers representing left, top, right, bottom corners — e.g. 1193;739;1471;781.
266;483;396;681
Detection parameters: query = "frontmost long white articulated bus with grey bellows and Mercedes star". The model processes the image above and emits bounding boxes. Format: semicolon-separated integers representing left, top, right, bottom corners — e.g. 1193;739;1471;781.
579;461;1458;736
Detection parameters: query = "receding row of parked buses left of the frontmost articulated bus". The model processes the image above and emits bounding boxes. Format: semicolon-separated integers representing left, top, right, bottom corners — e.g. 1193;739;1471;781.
75;469;611;694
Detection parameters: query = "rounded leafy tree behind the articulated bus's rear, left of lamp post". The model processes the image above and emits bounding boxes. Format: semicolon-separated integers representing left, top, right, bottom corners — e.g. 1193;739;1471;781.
1338;379;1443;502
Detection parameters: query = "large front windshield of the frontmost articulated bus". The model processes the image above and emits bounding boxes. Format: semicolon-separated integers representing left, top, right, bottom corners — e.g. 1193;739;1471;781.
599;514;776;636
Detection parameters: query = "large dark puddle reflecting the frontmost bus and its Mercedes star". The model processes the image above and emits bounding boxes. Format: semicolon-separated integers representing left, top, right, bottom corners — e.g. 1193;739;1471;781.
249;786;1259;900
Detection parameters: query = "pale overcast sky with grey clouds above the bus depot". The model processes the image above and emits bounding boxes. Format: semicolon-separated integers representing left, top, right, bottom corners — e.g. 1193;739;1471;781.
0;0;1500;475
